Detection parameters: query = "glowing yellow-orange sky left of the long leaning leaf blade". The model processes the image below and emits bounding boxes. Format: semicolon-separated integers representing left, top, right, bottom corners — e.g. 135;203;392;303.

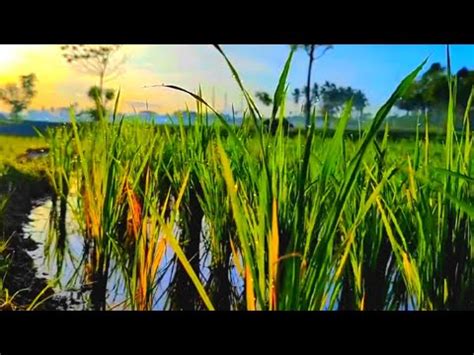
0;45;278;113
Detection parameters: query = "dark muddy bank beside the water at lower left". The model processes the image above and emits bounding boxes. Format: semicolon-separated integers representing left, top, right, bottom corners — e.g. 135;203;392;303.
0;168;66;310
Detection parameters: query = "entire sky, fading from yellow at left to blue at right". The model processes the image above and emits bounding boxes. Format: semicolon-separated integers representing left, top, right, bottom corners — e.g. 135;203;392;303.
0;44;474;114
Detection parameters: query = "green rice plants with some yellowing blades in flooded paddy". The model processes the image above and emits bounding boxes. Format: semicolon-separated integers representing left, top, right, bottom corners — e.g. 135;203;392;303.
0;46;474;311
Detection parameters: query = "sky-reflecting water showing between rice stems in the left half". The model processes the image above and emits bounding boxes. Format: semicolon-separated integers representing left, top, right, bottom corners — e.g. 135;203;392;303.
23;196;243;310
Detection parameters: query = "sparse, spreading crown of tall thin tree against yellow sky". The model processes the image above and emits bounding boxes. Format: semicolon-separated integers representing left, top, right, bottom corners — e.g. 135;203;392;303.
61;45;126;101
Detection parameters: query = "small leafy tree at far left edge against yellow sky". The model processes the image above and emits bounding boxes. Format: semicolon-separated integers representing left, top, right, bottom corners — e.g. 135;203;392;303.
0;73;37;117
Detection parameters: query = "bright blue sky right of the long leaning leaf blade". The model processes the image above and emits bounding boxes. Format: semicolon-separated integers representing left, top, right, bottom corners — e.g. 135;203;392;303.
225;45;474;113
